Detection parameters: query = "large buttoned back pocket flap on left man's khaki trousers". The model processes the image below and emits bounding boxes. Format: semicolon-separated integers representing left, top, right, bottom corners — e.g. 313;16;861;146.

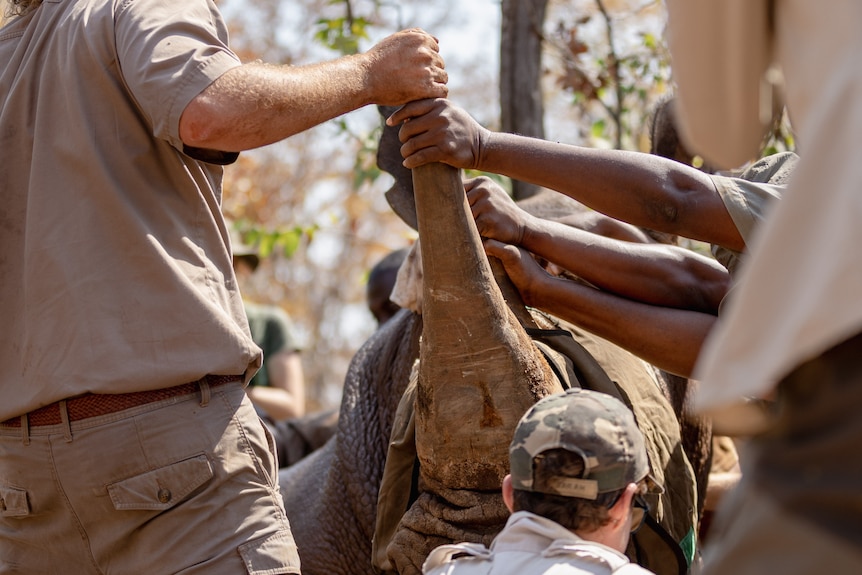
108;454;213;510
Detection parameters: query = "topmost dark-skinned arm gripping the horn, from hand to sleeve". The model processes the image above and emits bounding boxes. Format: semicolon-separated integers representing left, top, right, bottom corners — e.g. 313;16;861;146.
387;99;745;251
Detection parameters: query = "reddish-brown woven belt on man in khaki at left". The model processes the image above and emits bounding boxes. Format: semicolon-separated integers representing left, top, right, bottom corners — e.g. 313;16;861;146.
0;375;242;427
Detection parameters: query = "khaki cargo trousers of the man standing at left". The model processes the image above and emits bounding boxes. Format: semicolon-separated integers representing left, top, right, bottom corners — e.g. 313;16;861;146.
0;382;299;575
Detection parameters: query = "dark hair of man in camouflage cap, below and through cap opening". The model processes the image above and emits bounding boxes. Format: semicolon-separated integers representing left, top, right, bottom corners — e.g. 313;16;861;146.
506;449;624;532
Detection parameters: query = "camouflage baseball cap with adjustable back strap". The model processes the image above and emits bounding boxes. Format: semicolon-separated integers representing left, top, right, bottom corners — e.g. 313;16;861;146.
509;388;649;499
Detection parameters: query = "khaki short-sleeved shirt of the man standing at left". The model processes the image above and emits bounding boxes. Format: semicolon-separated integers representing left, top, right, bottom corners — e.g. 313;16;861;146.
0;0;260;420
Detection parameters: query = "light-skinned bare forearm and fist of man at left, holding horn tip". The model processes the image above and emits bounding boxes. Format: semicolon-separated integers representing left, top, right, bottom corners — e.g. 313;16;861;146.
185;30;447;152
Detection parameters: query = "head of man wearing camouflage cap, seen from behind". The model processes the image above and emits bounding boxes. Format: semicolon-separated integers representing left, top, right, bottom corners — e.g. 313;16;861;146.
503;389;655;551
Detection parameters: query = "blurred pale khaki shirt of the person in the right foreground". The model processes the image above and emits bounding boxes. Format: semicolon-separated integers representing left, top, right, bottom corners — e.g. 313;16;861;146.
667;0;862;424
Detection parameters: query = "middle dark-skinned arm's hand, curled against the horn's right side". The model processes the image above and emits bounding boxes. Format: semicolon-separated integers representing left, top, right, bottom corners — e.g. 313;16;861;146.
464;176;530;245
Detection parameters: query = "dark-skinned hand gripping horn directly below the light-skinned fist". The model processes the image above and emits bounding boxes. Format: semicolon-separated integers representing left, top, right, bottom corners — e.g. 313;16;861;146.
386;99;490;168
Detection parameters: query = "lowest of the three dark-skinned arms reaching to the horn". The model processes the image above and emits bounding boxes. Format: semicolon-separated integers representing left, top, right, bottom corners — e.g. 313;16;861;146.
485;240;717;377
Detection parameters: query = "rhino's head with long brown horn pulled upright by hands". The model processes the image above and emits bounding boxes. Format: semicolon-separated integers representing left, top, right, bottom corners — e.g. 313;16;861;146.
378;107;562;574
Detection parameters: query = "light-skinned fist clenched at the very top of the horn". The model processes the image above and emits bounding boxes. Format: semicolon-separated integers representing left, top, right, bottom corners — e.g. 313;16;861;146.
362;28;449;106
